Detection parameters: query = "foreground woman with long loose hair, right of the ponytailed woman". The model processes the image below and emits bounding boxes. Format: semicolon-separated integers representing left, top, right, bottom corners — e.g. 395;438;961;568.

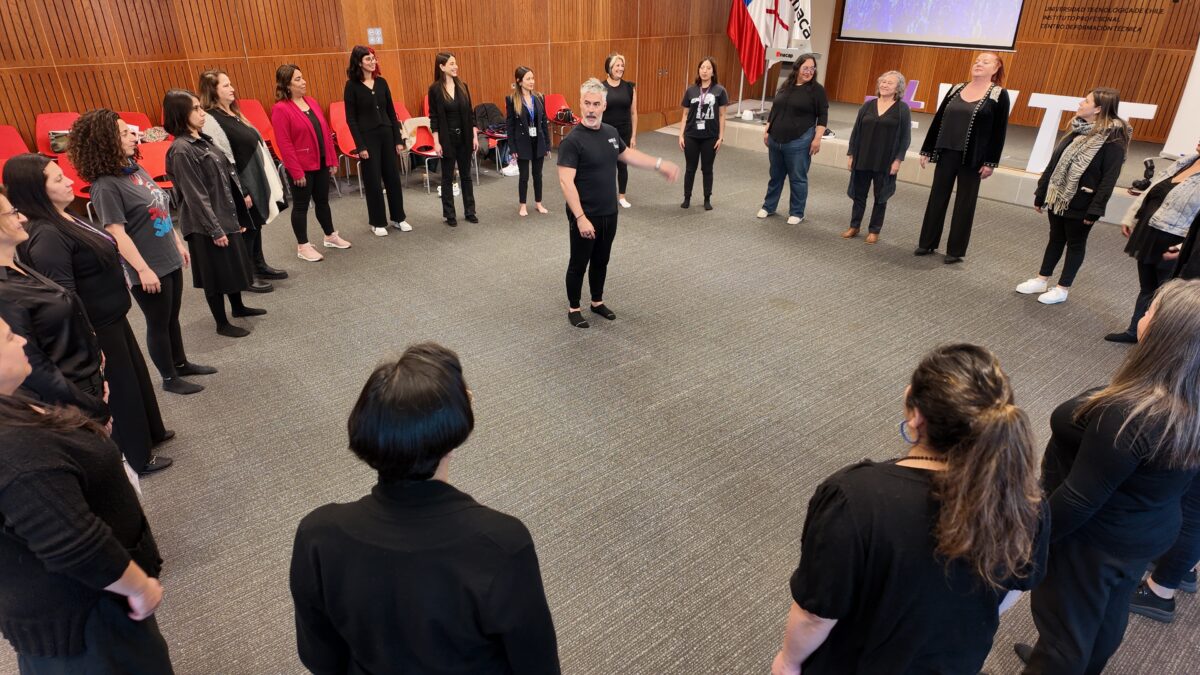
1016;280;1200;675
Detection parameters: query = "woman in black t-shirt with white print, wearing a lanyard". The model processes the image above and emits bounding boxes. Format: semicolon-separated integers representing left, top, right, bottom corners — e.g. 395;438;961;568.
676;56;730;211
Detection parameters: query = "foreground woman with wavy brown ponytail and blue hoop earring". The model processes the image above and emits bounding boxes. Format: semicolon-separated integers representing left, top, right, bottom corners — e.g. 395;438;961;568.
772;345;1049;675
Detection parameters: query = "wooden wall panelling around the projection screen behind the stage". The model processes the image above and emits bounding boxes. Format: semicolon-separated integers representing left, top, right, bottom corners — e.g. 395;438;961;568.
826;0;1200;142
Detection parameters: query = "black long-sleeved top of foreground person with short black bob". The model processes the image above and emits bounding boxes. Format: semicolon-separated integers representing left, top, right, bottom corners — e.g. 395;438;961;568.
290;480;559;675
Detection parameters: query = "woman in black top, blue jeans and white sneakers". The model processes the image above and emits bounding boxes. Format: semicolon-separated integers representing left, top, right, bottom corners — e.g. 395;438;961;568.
757;54;829;225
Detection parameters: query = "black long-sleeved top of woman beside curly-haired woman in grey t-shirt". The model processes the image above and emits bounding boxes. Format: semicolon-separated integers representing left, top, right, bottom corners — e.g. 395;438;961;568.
17;220;132;328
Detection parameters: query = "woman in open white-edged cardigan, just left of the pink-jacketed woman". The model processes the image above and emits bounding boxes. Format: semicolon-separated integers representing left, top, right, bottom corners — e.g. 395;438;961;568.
199;70;288;288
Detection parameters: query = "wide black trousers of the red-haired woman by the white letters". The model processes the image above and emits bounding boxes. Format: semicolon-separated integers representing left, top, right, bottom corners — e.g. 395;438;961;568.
918;150;982;257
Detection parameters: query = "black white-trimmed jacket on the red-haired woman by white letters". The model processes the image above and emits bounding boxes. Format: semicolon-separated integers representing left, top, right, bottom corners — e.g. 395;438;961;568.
920;84;1010;168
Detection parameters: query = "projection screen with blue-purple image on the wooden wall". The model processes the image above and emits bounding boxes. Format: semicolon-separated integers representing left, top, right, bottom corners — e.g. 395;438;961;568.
841;0;1024;49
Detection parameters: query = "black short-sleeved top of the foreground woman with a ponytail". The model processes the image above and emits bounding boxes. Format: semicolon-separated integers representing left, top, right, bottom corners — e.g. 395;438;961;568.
791;461;1050;675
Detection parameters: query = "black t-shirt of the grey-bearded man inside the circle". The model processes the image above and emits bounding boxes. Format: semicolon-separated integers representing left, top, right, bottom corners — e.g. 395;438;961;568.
558;124;625;219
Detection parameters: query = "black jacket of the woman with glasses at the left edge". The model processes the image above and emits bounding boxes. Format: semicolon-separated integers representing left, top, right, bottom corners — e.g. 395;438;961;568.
0;261;109;423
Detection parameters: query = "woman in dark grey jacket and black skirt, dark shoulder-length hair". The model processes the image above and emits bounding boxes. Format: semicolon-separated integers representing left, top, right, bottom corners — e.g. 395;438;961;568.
162;89;266;338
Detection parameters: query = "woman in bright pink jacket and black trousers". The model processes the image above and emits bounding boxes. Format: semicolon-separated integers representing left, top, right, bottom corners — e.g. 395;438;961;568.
271;64;350;263
